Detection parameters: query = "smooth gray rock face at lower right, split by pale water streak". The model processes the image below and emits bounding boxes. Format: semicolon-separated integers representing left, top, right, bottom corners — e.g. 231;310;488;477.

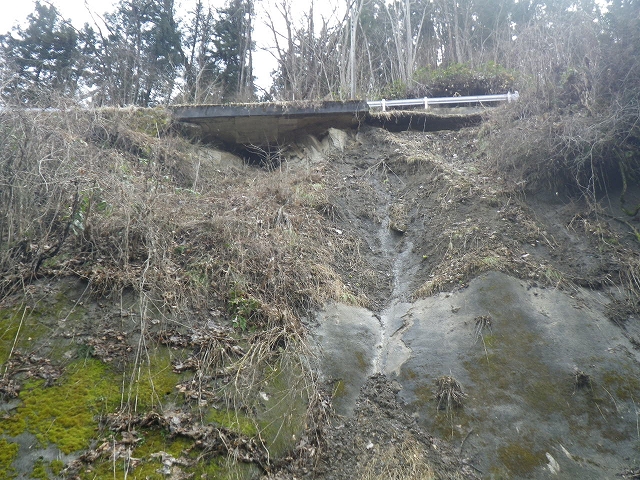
314;272;640;479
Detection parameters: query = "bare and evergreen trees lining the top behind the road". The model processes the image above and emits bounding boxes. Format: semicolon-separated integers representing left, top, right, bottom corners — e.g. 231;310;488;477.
0;0;640;107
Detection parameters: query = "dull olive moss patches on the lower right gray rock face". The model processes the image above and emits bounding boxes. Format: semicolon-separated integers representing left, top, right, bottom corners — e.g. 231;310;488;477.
458;282;640;472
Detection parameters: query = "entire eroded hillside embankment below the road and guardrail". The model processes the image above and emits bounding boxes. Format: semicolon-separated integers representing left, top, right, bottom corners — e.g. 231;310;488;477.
0;110;640;479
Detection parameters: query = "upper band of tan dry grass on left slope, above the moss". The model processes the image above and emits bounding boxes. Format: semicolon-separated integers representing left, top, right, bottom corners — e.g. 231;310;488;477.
0;110;362;323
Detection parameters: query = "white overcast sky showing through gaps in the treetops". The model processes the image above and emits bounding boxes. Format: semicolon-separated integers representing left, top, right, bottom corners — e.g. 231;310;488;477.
0;0;346;89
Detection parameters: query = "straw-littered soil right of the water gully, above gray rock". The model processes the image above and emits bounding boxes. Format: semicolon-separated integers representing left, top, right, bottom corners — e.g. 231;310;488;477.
372;125;638;298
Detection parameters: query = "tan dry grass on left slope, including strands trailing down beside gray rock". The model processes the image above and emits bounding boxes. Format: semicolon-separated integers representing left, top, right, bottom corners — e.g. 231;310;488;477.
0;104;367;472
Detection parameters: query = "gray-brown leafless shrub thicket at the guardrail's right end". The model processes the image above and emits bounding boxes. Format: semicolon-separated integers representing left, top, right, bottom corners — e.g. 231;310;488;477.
489;4;640;201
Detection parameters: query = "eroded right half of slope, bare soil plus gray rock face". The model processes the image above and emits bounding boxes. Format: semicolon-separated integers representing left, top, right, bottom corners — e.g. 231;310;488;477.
302;124;640;479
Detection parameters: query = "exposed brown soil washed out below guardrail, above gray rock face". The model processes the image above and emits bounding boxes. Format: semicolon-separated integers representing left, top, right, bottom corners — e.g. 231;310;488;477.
328;122;639;308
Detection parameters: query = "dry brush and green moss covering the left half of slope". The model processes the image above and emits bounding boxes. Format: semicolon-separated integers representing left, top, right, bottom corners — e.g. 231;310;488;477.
0;105;367;471
